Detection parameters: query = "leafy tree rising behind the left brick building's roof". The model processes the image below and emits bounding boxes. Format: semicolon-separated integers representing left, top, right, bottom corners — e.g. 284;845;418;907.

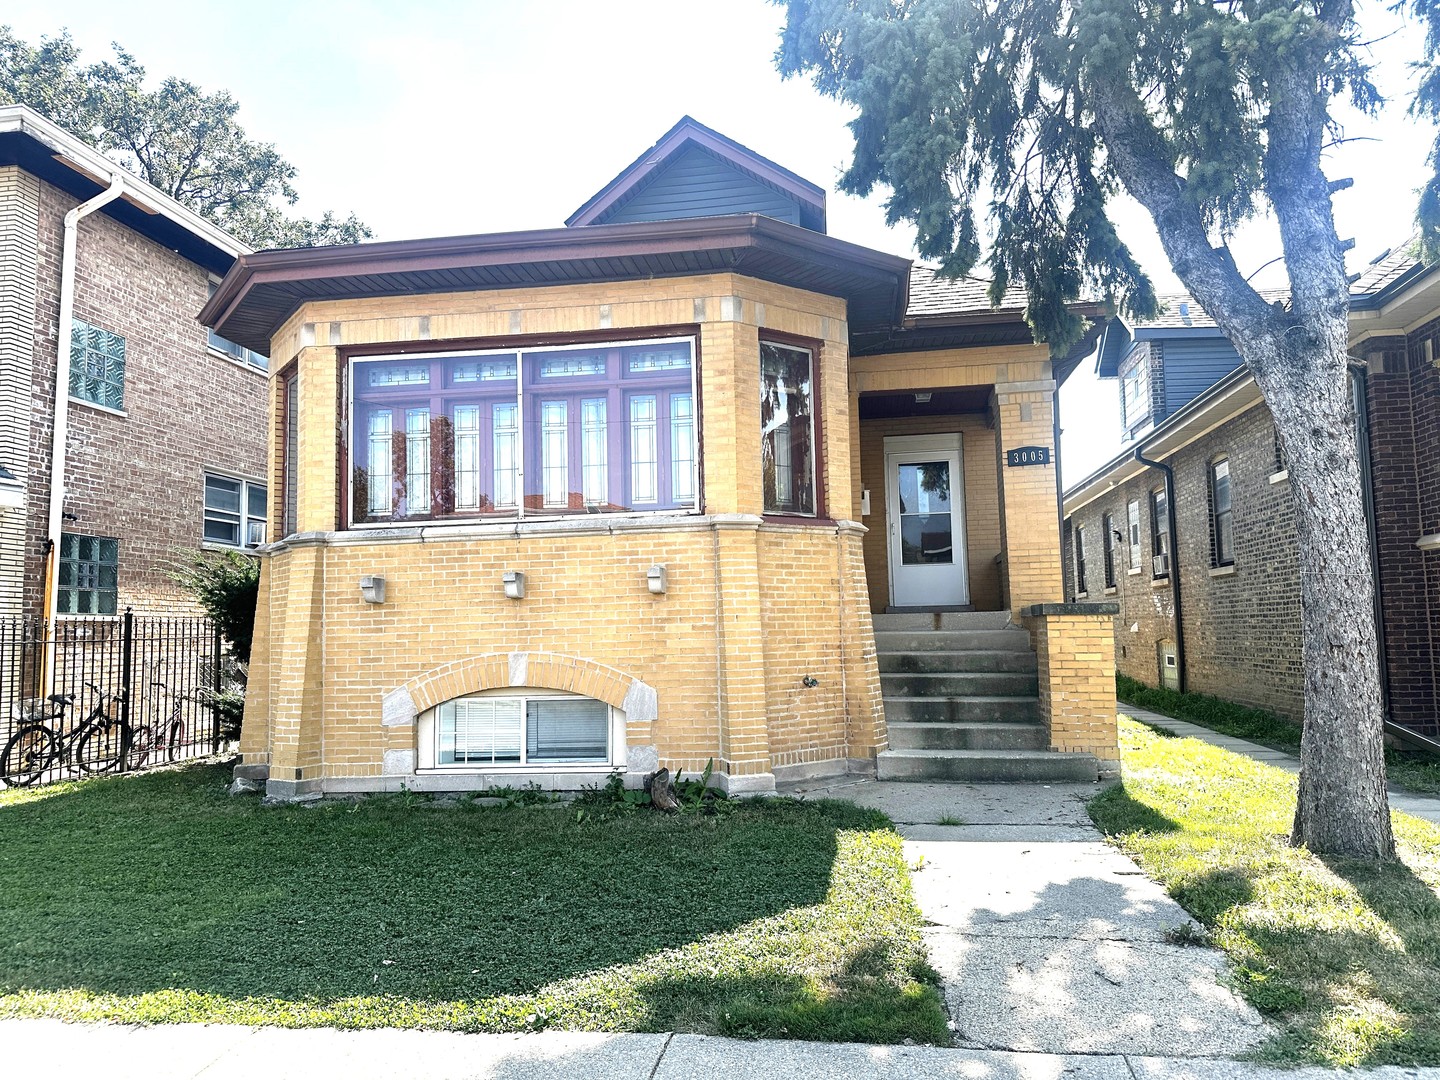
0;26;372;248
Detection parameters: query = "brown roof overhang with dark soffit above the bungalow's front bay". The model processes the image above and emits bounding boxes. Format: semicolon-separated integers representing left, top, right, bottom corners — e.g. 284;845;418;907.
200;215;910;354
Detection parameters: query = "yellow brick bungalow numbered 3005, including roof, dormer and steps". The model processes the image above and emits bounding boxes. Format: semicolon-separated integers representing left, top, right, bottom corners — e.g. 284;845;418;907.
202;118;1117;798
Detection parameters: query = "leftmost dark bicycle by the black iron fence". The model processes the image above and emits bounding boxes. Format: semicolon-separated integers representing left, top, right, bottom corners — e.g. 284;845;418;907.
0;683;130;788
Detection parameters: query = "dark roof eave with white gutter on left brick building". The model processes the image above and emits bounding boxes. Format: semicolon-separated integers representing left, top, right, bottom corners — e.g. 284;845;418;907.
0;105;251;274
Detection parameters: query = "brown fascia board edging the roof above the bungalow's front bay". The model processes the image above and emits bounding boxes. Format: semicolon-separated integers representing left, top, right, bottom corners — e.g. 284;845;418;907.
199;215;910;342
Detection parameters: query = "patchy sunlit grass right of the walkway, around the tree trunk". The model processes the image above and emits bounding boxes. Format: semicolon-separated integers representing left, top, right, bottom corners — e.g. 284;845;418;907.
1090;720;1440;1066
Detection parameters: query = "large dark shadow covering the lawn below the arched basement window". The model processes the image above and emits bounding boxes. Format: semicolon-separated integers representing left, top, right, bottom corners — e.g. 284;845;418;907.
0;768;887;1004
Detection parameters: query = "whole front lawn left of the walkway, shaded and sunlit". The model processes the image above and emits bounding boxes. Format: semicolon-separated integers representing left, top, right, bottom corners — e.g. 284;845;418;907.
0;766;949;1044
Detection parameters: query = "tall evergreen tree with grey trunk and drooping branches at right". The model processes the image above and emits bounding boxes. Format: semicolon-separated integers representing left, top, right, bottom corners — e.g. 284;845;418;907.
776;0;1440;858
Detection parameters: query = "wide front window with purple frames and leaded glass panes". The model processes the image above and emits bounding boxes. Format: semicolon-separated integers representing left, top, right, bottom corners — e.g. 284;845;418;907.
350;338;700;524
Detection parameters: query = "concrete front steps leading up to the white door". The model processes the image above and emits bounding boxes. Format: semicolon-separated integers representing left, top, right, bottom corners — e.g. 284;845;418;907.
873;612;1100;782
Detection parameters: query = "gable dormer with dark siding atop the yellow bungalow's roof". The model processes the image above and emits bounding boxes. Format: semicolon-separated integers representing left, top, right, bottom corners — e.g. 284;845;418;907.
564;117;825;232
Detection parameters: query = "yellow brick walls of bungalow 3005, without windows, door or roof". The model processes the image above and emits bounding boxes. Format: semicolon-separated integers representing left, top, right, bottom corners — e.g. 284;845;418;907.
242;274;1115;796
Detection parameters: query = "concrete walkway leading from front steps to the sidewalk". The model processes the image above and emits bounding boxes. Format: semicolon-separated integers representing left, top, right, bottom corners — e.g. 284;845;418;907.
792;780;1269;1057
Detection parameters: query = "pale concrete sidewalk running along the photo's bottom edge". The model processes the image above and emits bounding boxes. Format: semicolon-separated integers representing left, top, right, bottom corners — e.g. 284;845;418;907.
0;1020;1440;1080
